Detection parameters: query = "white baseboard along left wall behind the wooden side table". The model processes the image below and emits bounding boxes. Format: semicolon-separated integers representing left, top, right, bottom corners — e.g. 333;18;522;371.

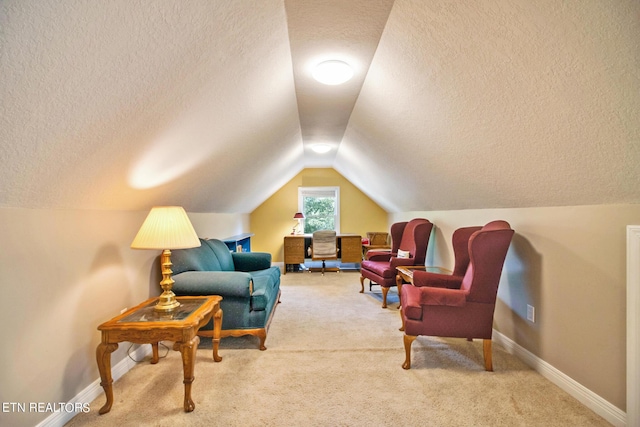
36;345;151;427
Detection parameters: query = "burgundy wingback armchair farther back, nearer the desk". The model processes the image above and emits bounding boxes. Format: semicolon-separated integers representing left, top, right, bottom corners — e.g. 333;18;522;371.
360;218;433;308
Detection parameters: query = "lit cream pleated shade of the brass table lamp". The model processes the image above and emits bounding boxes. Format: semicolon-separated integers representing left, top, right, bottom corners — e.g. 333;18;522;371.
131;206;200;250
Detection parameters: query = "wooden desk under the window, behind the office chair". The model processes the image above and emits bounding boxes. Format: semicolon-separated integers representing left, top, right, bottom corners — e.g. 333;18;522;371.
284;234;362;274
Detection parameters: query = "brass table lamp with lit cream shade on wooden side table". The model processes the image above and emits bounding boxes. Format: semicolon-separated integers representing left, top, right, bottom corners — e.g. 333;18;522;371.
131;206;200;312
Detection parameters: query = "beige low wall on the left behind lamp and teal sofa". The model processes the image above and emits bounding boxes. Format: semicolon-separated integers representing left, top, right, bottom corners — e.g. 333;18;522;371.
0;209;248;426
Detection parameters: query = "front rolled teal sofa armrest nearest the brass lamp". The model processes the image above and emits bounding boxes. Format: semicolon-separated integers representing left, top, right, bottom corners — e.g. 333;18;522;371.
173;271;253;298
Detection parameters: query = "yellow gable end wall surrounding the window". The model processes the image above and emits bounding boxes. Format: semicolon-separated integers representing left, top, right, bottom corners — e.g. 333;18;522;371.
250;168;389;262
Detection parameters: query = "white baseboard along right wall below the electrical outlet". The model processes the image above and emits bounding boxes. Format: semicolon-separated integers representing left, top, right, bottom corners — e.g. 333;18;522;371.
493;329;627;427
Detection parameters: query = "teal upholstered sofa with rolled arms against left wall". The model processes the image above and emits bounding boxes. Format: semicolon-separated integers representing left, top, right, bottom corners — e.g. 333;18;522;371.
171;239;280;350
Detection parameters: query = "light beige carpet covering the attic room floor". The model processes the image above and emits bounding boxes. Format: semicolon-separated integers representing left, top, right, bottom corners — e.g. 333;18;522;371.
67;272;609;427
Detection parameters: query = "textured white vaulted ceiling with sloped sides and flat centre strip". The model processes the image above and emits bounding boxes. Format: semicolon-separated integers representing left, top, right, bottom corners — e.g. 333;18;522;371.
0;0;640;213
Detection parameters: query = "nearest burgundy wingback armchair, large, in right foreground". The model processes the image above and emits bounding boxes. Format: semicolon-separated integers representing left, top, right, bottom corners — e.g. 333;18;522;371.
401;221;514;371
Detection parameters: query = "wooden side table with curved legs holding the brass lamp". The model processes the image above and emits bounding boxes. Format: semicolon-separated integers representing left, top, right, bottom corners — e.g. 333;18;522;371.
96;295;222;415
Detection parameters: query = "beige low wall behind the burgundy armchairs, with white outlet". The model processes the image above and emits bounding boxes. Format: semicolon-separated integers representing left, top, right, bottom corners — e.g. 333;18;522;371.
391;205;640;410
